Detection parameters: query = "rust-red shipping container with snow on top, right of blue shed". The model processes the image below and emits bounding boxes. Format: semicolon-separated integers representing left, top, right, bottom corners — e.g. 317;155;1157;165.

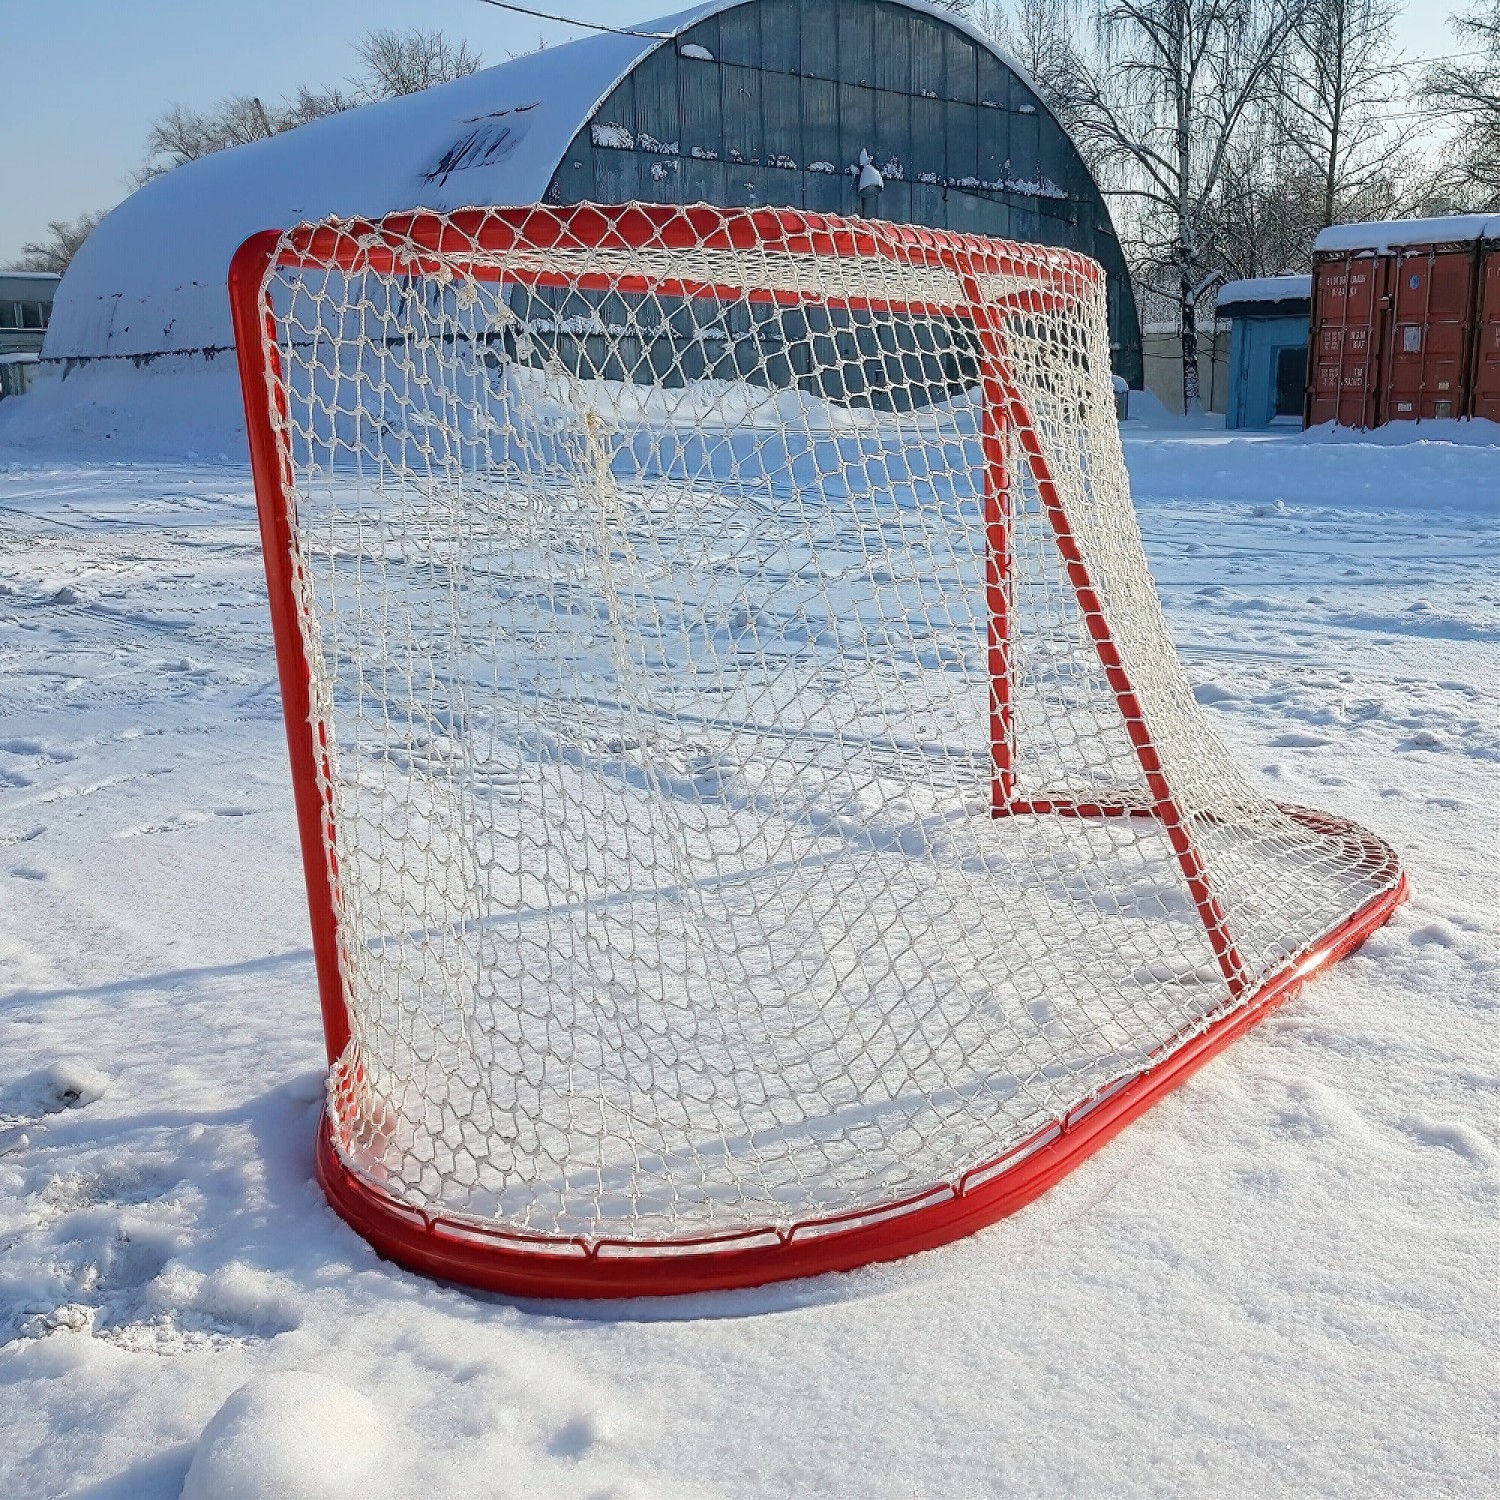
1305;215;1500;428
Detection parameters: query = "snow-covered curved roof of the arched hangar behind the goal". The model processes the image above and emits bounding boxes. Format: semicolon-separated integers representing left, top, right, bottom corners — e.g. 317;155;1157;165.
44;0;1044;359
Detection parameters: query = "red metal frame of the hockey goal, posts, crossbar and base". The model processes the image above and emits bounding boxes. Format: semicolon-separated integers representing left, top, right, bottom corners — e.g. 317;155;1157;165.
230;204;1407;1298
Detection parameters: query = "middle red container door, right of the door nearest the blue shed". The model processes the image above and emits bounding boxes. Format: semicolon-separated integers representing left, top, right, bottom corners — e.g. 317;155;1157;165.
1386;245;1475;422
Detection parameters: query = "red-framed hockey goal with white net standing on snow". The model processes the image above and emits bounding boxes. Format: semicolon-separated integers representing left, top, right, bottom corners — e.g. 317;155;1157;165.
231;204;1403;1296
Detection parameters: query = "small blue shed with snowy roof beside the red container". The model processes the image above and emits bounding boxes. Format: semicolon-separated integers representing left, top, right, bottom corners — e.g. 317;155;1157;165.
1218;276;1313;428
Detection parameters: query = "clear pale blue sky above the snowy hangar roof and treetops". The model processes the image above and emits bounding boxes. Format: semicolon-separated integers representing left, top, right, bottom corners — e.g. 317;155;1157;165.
0;0;1455;266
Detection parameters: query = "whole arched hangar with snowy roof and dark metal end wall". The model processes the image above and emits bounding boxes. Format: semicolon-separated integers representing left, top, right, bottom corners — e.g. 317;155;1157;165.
44;0;1142;386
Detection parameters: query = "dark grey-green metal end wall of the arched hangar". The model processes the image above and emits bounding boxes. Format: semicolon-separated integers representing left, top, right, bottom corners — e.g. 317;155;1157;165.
548;0;1142;387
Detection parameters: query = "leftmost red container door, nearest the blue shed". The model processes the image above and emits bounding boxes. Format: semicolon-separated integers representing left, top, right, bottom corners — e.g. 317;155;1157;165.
1308;255;1391;428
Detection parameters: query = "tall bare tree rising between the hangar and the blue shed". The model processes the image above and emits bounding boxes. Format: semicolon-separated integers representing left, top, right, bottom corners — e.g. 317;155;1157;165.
1074;0;1302;413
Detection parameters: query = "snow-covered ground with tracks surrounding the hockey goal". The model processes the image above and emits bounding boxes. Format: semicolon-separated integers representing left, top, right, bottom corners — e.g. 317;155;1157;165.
0;428;1500;1500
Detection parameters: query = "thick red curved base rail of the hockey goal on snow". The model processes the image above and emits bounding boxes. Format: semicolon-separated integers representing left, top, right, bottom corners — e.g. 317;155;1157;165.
318;858;1407;1298
